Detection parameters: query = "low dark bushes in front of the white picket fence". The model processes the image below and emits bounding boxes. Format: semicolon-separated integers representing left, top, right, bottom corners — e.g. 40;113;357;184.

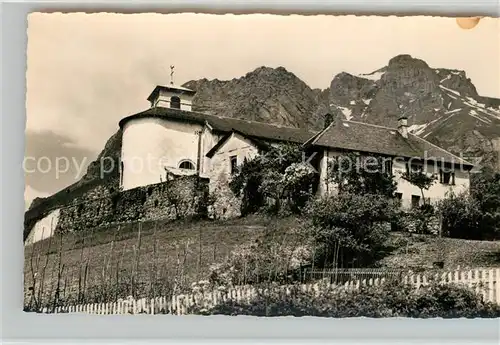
191;283;500;318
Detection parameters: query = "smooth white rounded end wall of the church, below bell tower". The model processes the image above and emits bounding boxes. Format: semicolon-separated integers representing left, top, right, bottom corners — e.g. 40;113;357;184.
121;118;201;190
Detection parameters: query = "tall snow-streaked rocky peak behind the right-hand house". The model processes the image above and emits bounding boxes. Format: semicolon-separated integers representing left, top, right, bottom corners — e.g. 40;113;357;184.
322;54;500;168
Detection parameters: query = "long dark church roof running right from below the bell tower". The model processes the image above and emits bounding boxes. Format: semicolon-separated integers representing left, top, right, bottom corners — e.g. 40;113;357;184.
119;107;317;144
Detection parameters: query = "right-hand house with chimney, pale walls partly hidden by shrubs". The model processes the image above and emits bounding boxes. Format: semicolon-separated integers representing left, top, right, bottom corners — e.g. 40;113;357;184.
304;115;473;207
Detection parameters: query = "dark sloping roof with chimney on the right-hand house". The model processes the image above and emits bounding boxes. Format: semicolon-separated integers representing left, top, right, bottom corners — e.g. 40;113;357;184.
305;119;473;167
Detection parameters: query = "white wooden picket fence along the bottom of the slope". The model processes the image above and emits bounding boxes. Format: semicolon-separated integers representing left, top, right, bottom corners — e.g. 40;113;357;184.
42;268;500;315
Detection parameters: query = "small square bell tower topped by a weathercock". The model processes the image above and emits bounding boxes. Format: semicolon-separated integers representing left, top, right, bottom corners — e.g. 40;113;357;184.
148;65;196;111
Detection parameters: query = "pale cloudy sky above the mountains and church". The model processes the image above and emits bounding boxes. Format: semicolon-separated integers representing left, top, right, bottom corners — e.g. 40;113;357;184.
25;13;500;206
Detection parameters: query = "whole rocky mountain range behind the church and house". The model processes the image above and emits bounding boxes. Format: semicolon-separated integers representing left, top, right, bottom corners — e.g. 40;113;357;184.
27;55;500;207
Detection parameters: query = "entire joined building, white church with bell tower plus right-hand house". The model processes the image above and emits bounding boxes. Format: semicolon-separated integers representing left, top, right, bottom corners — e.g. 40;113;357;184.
119;84;472;217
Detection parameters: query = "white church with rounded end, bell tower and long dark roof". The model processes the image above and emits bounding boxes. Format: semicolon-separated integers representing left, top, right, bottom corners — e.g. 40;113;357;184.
119;84;317;217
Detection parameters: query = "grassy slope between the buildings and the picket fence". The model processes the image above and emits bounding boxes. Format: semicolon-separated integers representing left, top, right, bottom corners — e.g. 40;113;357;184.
25;217;500;302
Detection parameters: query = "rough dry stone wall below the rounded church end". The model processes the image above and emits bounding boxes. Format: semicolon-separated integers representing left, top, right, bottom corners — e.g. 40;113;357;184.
25;176;208;236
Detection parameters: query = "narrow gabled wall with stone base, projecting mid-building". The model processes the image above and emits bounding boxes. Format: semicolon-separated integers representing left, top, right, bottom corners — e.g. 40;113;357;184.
209;134;259;219
